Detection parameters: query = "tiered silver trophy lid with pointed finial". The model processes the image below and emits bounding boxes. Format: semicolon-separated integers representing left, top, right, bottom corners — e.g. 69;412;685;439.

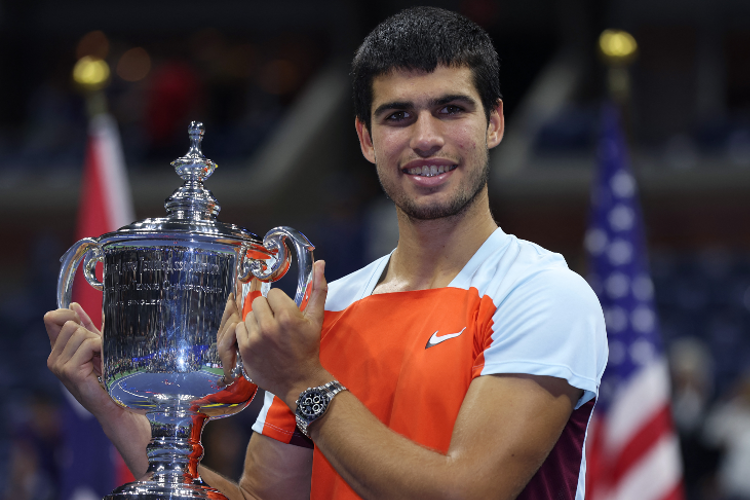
101;121;260;243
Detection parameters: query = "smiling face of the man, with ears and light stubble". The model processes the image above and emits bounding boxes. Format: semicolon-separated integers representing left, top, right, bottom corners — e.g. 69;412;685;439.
356;66;504;220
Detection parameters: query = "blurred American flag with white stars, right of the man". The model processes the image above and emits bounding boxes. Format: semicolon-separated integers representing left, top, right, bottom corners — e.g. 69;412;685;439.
585;104;684;500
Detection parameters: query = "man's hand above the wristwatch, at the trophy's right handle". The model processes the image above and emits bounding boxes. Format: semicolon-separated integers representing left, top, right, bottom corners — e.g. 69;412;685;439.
235;261;333;410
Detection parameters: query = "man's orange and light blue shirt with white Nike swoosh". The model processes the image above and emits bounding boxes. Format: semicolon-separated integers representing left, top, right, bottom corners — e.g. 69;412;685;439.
253;230;606;499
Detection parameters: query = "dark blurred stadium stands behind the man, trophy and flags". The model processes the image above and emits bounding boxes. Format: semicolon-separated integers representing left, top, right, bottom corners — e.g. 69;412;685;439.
0;0;750;499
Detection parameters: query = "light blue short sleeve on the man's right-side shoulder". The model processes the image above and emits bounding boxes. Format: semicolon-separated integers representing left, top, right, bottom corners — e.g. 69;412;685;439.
481;267;608;408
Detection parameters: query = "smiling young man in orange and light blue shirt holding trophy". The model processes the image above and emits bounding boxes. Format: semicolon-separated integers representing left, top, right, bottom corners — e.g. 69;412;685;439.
45;8;607;499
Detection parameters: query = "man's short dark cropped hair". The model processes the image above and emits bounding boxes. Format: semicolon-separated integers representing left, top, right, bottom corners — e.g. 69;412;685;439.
352;7;501;130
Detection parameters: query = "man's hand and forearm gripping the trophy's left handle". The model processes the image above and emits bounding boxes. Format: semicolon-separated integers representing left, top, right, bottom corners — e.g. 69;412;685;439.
44;303;151;477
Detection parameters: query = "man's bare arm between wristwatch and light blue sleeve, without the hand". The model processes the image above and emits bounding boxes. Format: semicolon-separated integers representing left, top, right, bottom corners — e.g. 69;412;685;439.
310;375;581;499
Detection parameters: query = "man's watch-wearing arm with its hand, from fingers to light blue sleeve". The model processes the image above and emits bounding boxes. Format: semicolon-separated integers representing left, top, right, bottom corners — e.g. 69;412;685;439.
236;262;582;499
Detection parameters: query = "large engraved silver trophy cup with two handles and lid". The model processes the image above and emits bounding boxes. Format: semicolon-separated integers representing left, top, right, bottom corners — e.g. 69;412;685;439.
57;122;313;500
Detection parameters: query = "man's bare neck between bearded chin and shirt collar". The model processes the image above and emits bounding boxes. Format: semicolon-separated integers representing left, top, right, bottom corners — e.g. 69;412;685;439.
374;187;497;293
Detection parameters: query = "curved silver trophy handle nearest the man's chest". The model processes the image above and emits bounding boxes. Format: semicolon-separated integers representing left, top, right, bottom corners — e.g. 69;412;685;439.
240;226;315;311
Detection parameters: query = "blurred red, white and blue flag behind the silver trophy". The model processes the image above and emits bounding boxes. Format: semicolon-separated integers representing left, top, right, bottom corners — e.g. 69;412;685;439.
59;113;135;500
